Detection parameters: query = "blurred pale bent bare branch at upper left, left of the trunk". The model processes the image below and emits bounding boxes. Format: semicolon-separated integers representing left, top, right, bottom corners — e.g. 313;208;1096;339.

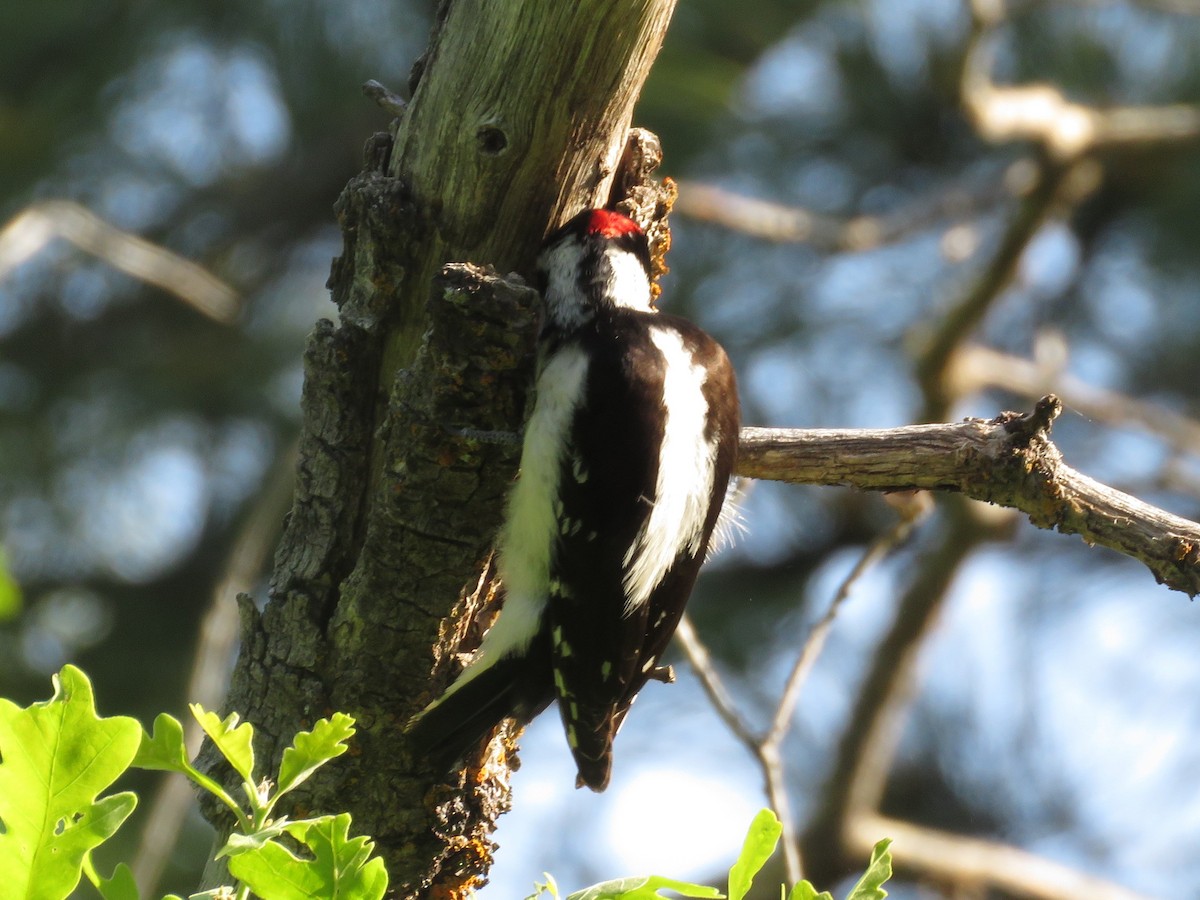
0;200;238;322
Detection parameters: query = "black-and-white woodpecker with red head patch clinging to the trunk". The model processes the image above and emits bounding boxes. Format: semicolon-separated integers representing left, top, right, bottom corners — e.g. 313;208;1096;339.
409;209;738;791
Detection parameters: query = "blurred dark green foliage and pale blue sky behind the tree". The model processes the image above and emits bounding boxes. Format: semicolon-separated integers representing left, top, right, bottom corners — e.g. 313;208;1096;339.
0;0;1200;899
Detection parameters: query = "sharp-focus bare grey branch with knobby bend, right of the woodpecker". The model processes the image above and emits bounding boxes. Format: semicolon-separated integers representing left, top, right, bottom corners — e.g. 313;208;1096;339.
738;396;1200;596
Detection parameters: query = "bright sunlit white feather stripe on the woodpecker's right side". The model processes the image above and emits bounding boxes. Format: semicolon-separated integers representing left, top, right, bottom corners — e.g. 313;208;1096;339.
624;326;716;614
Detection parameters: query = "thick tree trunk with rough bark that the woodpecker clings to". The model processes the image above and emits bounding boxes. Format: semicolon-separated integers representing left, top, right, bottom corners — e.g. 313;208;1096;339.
205;0;674;898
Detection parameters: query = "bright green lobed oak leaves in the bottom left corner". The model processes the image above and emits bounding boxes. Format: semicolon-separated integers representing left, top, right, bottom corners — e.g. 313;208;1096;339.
0;666;388;900
